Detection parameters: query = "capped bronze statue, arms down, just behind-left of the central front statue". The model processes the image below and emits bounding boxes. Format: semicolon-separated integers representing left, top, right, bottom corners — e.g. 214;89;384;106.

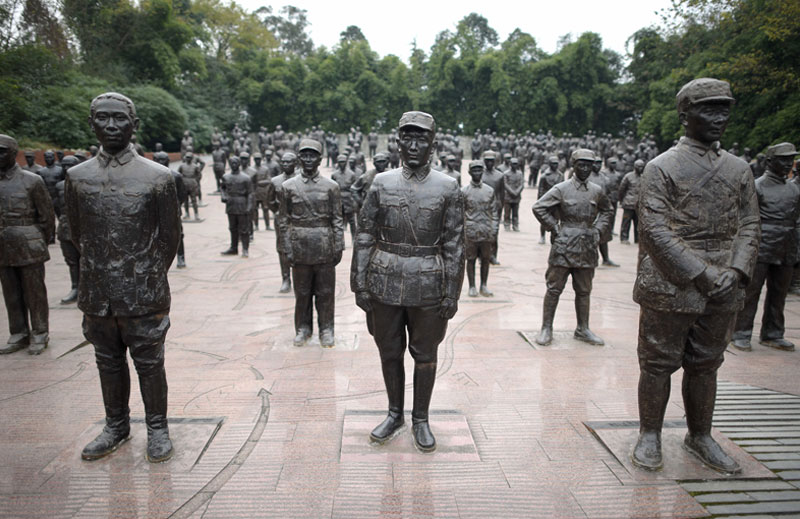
278;139;344;348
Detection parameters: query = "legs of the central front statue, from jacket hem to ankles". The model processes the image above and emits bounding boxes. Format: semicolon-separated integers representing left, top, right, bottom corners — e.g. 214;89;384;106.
367;300;447;421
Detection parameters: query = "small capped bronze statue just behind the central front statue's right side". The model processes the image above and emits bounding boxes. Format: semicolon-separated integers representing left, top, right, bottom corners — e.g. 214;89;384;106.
461;160;500;297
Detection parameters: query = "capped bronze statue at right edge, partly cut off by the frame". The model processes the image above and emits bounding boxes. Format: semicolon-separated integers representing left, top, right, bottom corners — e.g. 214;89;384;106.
731;142;800;351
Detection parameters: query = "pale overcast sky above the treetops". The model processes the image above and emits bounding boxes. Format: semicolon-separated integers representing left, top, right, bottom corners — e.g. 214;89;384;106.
237;0;671;62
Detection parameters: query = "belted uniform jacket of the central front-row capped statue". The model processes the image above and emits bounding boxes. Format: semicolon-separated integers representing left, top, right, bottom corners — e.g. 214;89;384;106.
350;168;464;306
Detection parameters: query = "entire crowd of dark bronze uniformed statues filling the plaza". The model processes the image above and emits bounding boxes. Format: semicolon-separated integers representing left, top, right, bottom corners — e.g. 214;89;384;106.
0;78;800;474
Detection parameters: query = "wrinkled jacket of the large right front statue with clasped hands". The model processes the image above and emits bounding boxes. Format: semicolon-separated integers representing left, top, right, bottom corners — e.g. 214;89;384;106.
633;137;760;314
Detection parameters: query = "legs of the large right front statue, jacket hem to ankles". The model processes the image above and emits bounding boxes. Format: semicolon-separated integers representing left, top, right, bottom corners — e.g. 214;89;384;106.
637;306;733;435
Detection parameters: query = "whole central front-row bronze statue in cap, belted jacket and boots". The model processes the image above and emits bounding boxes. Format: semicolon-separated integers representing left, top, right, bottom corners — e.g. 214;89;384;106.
350;112;464;452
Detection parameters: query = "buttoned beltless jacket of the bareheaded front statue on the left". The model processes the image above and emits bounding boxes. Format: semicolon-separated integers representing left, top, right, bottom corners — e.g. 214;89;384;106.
65;146;180;317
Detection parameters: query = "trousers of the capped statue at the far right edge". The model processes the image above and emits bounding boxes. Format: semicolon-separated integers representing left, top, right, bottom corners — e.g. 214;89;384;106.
733;262;794;341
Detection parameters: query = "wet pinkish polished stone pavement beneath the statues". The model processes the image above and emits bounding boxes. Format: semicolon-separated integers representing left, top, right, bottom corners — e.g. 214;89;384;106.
0;164;800;519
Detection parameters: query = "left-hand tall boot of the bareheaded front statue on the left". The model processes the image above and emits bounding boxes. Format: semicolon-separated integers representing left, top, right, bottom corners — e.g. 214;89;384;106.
81;367;131;461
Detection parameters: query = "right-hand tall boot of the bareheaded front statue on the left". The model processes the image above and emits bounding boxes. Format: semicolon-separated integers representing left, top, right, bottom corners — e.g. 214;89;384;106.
139;367;174;463
